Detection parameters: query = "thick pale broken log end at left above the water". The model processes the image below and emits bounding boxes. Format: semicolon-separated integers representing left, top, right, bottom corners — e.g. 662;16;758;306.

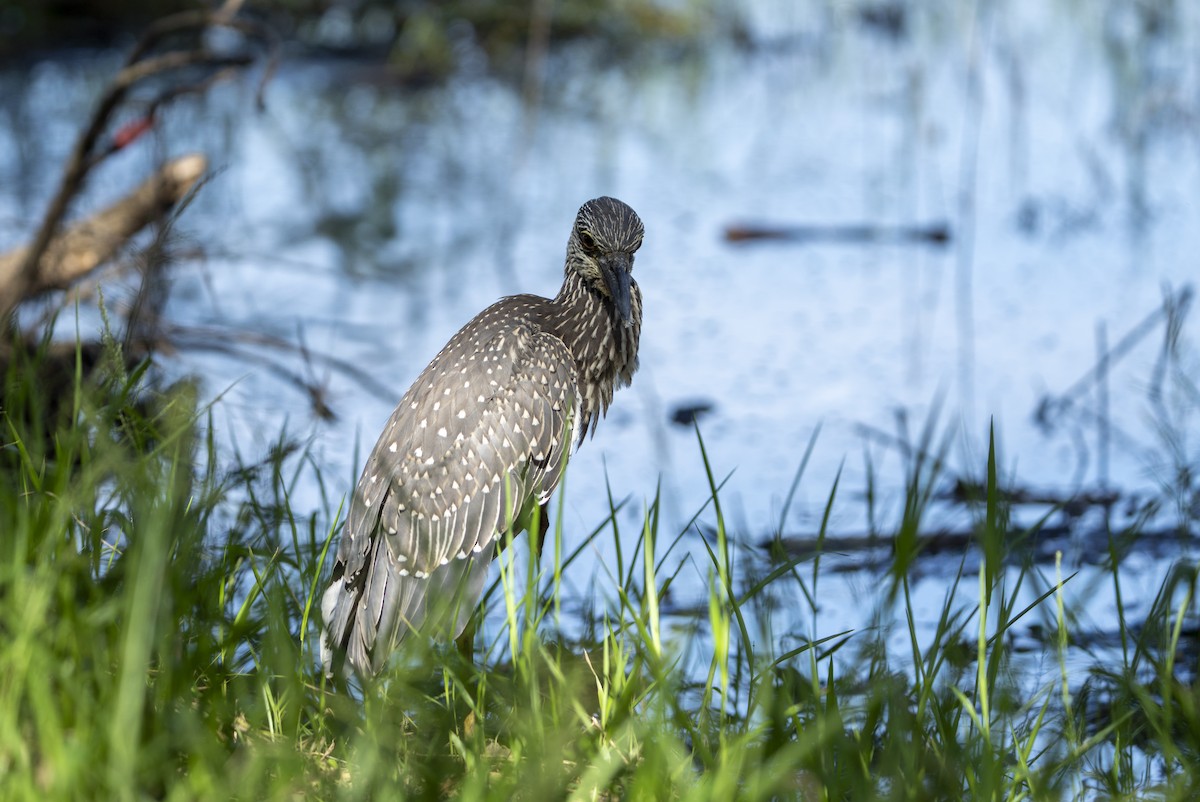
0;154;208;300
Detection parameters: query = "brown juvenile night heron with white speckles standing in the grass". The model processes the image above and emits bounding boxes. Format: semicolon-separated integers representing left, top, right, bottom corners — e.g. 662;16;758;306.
320;198;643;675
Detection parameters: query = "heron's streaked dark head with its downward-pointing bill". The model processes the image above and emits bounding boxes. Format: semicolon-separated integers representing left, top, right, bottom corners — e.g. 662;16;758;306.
566;197;644;327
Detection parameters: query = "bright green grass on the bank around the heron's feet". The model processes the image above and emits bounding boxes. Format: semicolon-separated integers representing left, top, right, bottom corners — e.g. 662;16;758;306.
0;336;1200;800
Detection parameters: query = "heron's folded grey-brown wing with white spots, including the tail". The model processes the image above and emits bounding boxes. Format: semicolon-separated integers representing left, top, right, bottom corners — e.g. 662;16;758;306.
322;303;578;671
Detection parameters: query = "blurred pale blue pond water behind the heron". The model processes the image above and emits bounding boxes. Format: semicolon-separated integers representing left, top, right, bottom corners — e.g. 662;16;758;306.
0;0;1200;677
